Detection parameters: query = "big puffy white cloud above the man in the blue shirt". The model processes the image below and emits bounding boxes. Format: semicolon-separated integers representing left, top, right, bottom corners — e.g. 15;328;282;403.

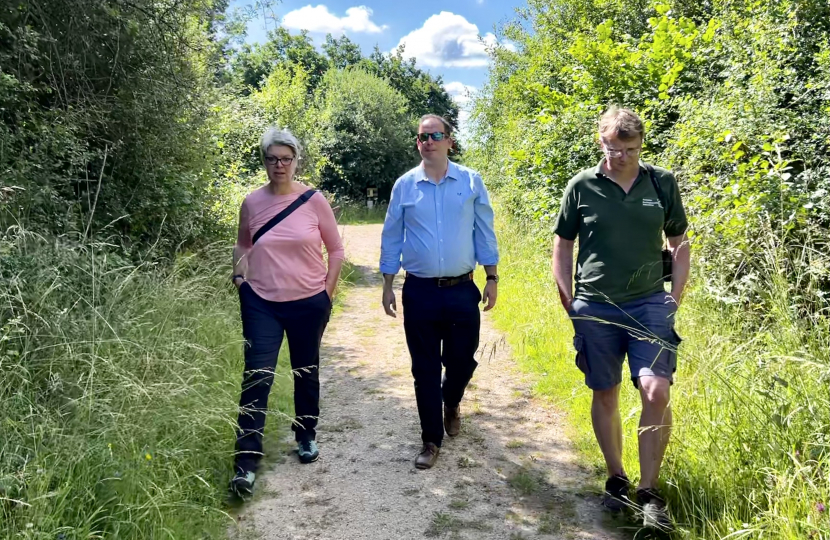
398;11;508;68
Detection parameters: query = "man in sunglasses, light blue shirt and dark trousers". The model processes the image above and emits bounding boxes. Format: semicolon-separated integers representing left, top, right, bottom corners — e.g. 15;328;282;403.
380;114;499;469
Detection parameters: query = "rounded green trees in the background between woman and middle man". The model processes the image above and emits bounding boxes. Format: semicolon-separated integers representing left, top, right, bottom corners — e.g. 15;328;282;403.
216;33;458;207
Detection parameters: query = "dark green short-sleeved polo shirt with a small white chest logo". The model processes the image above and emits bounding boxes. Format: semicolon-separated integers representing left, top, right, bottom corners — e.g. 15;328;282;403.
555;160;688;304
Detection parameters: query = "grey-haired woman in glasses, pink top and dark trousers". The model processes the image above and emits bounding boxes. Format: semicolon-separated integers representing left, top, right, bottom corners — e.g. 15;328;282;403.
231;128;343;496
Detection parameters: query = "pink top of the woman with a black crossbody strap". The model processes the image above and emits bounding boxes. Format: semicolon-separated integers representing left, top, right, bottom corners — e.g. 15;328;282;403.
237;184;345;302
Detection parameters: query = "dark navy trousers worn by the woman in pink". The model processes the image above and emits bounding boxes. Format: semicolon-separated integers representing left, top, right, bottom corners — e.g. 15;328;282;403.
236;283;331;471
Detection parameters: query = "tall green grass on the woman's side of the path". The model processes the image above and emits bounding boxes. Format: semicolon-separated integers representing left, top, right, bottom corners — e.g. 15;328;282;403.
0;232;292;540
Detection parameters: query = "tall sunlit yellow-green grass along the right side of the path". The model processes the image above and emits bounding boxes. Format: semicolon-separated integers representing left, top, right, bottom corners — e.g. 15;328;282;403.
493;215;830;540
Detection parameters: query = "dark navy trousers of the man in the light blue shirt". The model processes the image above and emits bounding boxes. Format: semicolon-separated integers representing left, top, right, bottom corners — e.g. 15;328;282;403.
402;275;481;446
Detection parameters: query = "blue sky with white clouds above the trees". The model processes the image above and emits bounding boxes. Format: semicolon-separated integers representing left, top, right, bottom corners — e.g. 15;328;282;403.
231;0;525;133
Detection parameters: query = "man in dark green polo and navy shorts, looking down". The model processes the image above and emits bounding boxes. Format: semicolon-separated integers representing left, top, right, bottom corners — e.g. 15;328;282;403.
553;108;690;528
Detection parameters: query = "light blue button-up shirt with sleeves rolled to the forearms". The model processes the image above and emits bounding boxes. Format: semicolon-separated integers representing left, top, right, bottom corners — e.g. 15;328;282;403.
380;161;499;277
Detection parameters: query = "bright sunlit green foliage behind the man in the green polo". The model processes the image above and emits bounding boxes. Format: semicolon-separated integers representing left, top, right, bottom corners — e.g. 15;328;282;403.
473;0;830;309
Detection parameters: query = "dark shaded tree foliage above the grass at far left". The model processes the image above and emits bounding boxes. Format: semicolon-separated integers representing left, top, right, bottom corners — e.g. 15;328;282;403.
0;0;231;249
